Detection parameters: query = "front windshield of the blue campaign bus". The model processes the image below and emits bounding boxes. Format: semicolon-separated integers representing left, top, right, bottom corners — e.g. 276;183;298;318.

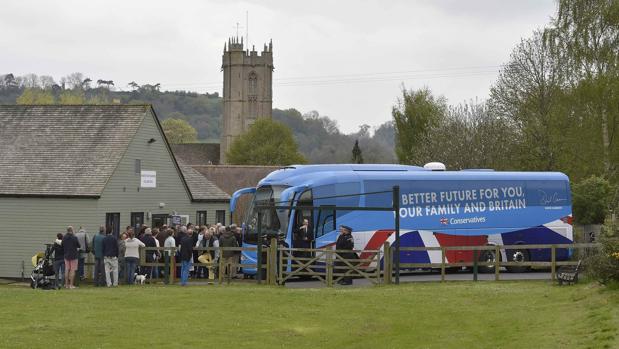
243;185;288;244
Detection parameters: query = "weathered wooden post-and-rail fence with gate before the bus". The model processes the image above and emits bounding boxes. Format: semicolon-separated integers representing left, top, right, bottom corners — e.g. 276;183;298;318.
132;239;599;287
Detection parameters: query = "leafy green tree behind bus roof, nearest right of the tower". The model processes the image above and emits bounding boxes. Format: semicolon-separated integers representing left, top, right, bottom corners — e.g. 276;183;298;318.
391;87;447;164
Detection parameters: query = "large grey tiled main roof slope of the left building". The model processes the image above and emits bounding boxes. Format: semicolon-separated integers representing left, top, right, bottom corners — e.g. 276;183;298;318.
0;105;151;197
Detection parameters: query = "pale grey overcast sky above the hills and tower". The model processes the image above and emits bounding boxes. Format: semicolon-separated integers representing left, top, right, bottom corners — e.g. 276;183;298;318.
0;0;555;132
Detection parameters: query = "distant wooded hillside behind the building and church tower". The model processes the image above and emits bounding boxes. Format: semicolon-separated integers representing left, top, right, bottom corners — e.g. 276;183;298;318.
0;73;396;163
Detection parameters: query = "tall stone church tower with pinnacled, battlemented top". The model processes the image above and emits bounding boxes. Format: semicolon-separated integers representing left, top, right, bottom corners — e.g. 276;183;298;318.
219;37;273;164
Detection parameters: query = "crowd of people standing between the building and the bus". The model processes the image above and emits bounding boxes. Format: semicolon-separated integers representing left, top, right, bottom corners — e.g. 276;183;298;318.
52;223;241;289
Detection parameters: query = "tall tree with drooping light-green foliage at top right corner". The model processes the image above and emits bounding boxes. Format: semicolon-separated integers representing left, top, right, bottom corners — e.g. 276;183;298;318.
551;0;619;176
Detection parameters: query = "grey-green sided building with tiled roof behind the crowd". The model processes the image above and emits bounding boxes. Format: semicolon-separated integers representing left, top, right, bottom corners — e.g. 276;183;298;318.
0;105;230;277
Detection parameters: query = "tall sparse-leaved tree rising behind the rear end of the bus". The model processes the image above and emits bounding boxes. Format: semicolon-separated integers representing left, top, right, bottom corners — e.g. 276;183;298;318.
490;31;569;170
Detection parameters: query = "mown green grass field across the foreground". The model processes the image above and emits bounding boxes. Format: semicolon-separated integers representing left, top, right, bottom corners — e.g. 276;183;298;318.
0;281;619;349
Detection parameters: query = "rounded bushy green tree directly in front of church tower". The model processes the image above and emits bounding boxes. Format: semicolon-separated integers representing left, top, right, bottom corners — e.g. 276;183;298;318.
226;118;306;166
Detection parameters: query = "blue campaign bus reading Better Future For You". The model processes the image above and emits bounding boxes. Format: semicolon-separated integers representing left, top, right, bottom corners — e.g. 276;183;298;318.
230;164;573;274
